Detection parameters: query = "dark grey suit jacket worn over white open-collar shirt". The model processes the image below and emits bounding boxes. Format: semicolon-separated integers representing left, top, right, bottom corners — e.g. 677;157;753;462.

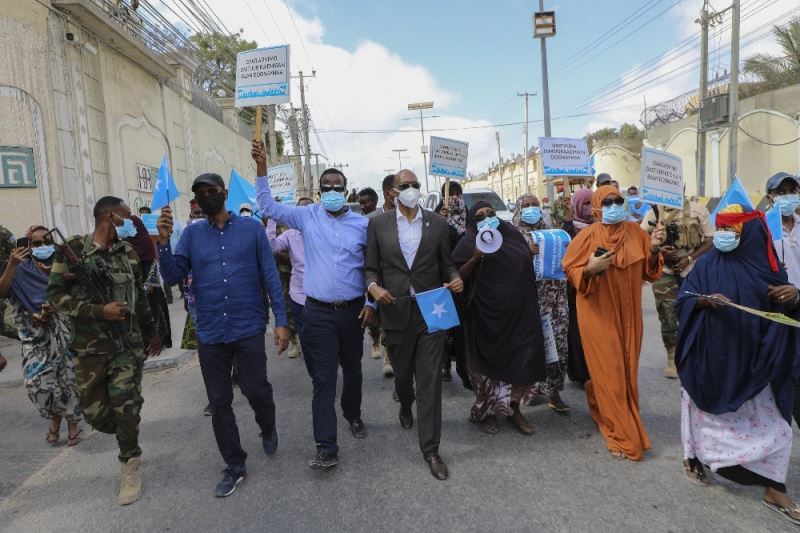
364;207;458;331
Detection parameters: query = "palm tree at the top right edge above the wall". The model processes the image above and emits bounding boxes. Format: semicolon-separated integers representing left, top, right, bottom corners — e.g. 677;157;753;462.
744;18;800;92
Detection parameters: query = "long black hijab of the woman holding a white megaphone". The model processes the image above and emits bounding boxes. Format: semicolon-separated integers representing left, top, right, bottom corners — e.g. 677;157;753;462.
453;202;546;385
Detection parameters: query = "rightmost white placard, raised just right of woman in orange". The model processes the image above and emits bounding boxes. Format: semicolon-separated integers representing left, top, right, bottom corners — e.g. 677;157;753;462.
640;148;683;208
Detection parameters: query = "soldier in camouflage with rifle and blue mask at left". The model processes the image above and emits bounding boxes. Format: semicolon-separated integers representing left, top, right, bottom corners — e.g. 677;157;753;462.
47;196;161;505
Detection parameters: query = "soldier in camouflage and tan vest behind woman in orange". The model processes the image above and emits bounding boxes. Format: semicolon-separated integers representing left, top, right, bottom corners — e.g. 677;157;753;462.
641;199;714;379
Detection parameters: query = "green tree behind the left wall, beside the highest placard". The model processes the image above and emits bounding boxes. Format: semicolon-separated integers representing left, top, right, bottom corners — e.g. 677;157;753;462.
189;30;258;97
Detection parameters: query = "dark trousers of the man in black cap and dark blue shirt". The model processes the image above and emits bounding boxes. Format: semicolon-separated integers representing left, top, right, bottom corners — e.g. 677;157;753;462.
197;333;275;466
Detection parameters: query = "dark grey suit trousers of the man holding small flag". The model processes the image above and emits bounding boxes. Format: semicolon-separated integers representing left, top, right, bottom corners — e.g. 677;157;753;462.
384;305;447;455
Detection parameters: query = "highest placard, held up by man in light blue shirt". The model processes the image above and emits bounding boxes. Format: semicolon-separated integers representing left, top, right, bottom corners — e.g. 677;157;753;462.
234;44;291;108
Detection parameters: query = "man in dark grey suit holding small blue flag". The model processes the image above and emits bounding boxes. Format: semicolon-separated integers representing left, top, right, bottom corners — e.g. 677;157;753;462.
364;170;464;480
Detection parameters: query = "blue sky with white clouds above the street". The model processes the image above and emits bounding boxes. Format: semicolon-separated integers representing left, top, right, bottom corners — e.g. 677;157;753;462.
184;0;800;187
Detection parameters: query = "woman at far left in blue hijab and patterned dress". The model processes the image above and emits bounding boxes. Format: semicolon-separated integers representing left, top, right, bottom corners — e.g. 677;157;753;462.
0;226;81;446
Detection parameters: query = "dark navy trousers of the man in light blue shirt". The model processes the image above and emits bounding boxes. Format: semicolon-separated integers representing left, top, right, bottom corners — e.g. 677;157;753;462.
300;298;364;455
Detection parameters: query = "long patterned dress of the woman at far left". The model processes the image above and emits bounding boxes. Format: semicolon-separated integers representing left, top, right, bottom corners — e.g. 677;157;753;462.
10;297;82;422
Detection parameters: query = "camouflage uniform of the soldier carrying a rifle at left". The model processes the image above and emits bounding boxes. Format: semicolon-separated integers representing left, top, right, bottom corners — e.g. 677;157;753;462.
47;234;158;462
